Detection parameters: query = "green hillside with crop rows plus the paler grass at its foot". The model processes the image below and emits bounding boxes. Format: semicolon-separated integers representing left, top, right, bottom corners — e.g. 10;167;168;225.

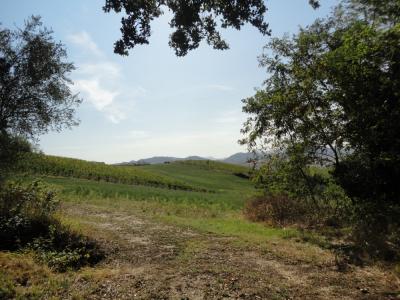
18;154;257;232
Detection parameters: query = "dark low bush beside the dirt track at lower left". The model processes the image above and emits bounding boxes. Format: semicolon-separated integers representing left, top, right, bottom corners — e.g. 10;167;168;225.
0;181;104;271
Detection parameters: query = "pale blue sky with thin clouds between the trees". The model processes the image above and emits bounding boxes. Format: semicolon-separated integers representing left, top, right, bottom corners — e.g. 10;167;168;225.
0;0;338;163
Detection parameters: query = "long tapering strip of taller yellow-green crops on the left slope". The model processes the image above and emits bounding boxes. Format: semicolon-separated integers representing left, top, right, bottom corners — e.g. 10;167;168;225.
15;152;204;191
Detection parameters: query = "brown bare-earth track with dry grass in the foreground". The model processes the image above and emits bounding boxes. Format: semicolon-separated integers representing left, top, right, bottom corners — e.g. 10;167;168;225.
61;206;400;299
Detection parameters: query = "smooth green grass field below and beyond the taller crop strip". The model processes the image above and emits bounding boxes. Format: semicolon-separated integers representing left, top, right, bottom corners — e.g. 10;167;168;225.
16;157;294;242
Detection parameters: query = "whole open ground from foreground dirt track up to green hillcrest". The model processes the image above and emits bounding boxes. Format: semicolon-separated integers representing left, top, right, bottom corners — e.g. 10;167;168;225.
0;158;399;299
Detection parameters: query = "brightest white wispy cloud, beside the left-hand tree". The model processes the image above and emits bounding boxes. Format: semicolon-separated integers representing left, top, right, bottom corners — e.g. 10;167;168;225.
69;31;146;123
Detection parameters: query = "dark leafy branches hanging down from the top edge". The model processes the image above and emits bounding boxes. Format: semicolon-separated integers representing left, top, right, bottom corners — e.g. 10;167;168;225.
103;0;319;56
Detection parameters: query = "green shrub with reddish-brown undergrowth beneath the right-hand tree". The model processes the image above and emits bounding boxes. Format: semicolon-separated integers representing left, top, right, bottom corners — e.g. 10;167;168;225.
246;155;350;227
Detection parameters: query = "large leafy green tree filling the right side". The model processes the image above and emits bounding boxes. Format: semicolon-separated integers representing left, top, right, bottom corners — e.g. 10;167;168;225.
243;0;400;255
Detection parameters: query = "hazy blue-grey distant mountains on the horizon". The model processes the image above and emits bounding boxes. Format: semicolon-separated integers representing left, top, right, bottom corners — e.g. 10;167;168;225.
117;152;260;165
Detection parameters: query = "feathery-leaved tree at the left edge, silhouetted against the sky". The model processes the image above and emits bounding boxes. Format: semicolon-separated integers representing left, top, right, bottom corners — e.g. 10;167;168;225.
0;16;81;173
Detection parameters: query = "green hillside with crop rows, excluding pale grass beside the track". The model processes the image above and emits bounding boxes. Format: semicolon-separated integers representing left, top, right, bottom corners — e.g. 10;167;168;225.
18;154;255;214
